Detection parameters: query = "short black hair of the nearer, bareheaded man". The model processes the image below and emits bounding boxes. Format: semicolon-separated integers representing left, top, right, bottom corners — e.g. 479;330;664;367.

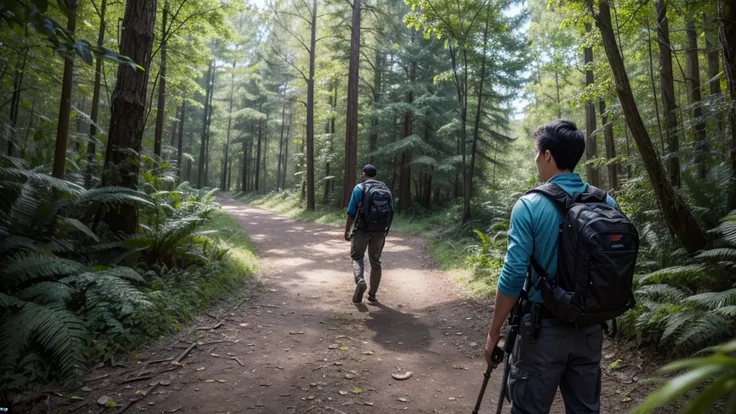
534;119;585;171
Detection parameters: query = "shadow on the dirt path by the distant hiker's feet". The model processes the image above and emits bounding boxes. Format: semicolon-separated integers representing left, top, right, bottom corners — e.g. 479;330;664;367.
365;303;432;352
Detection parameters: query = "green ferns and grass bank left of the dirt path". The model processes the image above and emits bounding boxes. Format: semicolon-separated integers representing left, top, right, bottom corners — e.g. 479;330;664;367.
0;159;255;390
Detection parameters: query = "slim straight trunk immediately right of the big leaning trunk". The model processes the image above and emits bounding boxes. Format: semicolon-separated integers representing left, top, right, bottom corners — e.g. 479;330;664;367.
657;0;680;187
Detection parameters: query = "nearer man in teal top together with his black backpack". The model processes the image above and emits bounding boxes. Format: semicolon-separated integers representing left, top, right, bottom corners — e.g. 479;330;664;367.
485;120;639;414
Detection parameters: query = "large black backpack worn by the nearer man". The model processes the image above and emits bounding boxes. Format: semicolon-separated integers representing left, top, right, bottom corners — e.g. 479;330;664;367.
527;183;639;326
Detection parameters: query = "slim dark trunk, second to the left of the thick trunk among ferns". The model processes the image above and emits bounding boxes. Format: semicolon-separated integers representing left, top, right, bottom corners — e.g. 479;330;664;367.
51;0;77;178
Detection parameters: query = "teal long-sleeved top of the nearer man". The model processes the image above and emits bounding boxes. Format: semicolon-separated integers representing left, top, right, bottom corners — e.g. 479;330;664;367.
498;173;617;303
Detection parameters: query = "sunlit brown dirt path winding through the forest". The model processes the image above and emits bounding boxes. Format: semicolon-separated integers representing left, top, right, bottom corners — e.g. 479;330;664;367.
60;200;652;414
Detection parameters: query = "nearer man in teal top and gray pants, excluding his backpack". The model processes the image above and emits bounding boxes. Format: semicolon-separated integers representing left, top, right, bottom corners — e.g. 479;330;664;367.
485;120;616;414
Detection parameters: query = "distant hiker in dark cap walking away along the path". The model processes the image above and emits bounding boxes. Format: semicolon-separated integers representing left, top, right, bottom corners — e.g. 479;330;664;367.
345;164;394;304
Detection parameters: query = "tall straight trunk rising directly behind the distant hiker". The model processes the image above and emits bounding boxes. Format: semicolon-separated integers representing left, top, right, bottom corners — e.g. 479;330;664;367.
341;0;360;207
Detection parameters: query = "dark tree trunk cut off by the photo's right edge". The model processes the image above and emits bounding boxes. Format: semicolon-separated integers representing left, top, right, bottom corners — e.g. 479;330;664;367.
718;0;736;211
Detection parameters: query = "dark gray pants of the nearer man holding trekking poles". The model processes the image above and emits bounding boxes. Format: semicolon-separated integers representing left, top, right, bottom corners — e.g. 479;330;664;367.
508;319;603;414
